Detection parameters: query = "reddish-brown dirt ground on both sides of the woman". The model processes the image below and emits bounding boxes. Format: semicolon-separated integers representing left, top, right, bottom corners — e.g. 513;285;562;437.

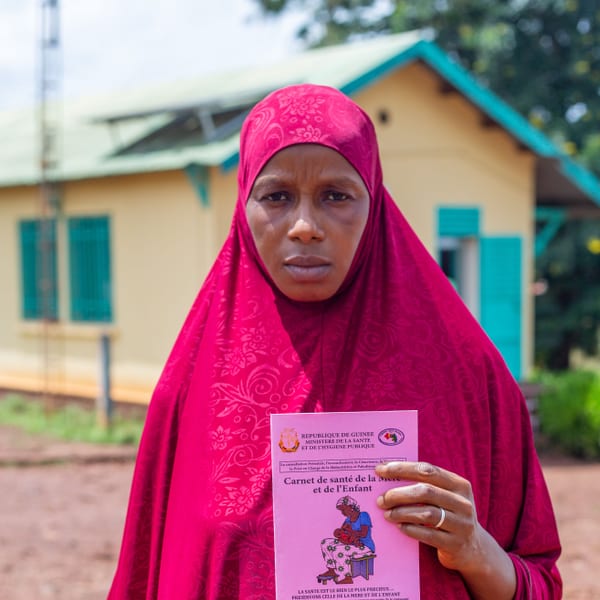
0;427;600;600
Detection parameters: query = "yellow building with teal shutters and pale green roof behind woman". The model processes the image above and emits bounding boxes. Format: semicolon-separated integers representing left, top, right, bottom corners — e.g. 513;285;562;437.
0;34;600;402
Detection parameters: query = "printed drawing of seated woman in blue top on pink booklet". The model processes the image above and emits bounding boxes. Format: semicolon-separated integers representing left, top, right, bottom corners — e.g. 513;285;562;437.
317;496;375;585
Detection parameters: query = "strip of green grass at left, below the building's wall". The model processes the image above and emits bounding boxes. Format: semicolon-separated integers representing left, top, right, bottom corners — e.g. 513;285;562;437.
0;394;144;445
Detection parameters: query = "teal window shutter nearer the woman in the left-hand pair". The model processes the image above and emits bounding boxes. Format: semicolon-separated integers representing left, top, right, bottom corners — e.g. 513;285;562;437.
68;217;112;322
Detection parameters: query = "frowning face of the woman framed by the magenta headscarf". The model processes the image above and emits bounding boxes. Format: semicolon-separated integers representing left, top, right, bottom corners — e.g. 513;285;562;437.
246;144;370;302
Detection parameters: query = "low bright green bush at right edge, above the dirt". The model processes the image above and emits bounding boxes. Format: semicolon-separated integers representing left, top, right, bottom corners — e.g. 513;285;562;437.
538;371;600;459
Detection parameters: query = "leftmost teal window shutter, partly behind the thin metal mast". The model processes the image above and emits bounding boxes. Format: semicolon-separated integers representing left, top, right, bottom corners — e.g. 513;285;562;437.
19;219;58;321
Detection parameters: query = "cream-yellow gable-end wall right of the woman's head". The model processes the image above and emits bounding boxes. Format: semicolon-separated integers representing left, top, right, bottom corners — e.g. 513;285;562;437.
355;64;535;374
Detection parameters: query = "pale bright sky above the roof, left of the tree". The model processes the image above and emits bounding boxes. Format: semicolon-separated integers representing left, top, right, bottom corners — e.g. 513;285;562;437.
0;0;302;110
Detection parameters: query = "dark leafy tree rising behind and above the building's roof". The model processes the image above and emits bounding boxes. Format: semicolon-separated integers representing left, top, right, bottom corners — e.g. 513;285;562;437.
255;0;600;173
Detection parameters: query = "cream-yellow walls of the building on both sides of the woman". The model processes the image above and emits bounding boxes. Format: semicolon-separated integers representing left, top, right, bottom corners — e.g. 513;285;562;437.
0;65;534;402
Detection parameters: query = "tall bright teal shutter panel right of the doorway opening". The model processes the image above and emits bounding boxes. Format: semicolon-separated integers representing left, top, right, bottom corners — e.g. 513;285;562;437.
480;237;523;379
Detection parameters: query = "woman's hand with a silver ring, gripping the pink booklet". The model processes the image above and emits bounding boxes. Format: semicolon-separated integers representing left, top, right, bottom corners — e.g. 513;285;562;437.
375;462;516;600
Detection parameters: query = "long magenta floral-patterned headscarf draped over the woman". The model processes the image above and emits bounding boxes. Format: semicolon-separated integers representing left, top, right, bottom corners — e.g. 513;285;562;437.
109;85;561;600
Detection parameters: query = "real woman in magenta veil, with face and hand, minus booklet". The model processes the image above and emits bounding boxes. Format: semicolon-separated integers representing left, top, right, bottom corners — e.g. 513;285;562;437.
110;85;561;600
